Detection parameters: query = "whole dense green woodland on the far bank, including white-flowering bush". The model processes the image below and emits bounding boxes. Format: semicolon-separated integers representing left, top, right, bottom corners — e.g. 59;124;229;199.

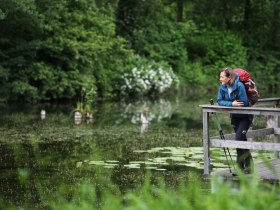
0;0;280;102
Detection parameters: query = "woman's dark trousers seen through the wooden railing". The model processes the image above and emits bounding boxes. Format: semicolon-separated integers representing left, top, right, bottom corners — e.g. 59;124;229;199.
231;115;253;170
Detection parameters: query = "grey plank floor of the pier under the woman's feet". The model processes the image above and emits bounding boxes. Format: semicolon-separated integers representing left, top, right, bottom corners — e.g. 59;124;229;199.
211;158;280;181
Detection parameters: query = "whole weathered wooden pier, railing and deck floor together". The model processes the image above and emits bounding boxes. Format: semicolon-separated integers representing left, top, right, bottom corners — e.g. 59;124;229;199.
200;98;280;181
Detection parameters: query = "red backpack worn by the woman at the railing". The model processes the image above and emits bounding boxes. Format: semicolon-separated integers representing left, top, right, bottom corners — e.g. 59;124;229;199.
233;68;260;106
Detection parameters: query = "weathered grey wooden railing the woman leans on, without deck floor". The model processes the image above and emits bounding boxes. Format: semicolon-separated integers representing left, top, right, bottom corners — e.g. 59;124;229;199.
200;98;280;175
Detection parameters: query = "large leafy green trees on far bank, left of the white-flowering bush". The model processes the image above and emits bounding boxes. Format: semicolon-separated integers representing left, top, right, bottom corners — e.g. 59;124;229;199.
0;0;135;101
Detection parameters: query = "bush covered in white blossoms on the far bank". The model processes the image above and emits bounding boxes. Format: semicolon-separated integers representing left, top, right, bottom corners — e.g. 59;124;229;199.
121;58;179;95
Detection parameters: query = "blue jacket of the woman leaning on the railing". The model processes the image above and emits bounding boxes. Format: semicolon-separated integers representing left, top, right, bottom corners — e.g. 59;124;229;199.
217;74;249;107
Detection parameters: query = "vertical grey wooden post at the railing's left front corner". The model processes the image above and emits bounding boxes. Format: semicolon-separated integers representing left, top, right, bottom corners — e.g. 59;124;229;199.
203;111;210;175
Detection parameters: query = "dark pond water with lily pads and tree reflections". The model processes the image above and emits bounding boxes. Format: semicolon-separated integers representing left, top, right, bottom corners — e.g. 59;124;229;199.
0;98;272;208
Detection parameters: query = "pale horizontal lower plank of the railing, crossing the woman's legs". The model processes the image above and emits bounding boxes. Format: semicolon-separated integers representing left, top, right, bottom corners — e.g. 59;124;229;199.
210;139;280;151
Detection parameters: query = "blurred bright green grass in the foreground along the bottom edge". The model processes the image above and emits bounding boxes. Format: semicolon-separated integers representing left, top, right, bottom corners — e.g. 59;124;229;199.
35;173;280;210
